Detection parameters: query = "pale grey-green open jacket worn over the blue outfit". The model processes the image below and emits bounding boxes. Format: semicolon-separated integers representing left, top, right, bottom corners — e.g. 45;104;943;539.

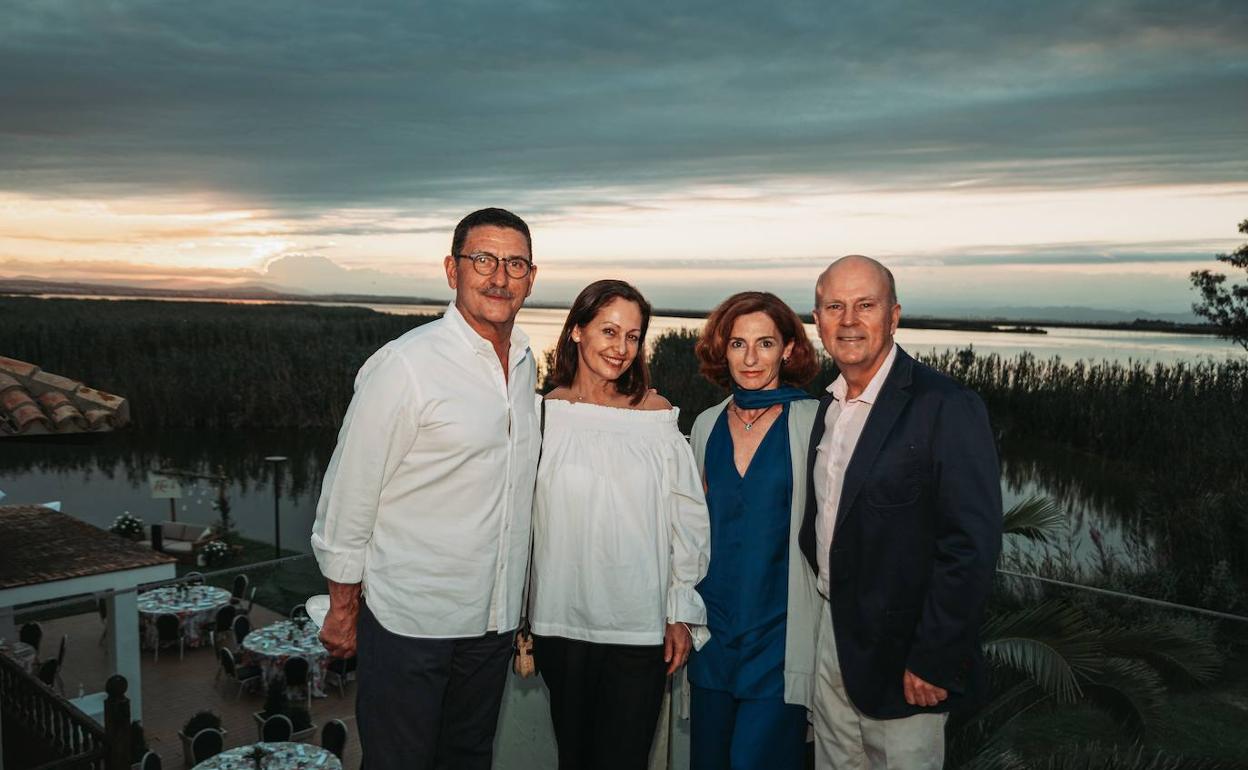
689;397;822;709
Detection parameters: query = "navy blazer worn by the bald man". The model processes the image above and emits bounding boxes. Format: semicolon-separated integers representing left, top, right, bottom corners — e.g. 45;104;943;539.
797;348;1002;719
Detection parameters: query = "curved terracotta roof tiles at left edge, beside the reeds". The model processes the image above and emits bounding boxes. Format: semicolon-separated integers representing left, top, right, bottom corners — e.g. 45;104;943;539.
0;356;130;437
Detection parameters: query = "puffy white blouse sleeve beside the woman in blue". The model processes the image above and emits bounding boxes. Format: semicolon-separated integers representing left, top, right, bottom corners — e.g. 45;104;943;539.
668;439;710;649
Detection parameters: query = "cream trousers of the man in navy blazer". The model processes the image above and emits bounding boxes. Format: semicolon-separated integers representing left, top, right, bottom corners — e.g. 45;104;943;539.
814;602;948;770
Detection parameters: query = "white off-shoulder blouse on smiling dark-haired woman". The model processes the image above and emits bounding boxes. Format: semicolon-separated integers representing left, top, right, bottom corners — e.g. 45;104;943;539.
532;399;710;646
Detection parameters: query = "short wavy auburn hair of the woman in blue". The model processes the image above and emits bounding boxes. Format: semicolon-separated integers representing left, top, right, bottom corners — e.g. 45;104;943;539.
694;292;819;388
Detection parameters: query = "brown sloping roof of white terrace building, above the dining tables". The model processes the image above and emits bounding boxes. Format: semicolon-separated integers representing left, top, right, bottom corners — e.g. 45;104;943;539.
0;505;175;589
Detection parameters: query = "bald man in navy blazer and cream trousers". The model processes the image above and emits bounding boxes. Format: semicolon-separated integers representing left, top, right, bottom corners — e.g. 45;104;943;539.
799;256;1002;770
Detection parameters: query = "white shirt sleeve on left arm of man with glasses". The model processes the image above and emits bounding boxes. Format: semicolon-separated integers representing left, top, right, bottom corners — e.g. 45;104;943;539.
312;348;419;583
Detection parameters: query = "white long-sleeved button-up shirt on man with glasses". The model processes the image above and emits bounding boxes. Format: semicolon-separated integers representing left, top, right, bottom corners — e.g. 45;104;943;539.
312;303;540;638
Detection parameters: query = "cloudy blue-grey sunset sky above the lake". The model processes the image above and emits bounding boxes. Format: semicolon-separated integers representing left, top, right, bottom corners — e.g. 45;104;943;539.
0;0;1248;313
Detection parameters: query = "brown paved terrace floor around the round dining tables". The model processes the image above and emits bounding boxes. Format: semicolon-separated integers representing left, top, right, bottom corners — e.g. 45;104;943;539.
31;604;359;770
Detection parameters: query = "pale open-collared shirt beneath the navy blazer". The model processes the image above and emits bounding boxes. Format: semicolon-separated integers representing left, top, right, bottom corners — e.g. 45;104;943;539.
815;343;897;597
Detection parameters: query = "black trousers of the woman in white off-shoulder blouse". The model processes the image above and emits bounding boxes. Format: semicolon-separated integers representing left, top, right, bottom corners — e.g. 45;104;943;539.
533;636;668;770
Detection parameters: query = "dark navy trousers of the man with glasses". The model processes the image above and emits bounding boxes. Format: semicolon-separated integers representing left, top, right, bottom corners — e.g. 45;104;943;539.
356;605;512;770
